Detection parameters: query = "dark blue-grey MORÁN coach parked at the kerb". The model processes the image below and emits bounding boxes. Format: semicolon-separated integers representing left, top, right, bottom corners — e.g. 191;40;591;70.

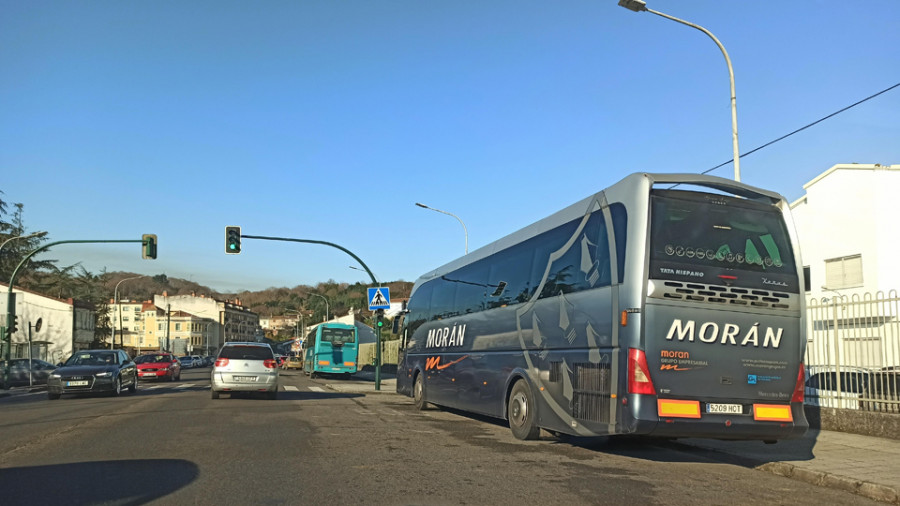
397;174;808;441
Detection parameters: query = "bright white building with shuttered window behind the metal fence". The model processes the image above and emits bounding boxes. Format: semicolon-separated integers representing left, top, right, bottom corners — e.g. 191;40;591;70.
791;164;900;299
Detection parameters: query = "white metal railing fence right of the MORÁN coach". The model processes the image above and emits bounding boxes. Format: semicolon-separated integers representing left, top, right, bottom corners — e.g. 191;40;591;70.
805;290;900;413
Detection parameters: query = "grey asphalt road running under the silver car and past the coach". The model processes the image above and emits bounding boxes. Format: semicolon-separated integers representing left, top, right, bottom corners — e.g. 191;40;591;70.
0;368;873;505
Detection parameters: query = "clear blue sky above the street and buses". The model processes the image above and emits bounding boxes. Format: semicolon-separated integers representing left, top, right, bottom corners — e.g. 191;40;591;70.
0;0;900;291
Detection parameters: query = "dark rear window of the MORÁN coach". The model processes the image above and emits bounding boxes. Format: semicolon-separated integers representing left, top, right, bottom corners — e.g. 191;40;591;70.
650;190;797;286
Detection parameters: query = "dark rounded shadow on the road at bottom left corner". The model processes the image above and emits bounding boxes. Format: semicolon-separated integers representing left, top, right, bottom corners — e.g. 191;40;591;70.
0;459;200;505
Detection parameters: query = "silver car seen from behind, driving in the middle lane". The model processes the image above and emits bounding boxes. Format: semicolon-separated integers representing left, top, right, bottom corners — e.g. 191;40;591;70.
210;342;278;399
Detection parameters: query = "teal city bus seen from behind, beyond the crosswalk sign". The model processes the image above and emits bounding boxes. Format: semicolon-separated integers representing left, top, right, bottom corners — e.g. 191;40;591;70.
303;323;359;377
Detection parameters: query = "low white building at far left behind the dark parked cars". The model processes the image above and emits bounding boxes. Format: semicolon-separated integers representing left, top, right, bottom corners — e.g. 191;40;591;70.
0;284;96;364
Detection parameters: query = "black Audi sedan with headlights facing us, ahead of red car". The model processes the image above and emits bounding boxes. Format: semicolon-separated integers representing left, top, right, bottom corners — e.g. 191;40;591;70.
47;350;137;399
